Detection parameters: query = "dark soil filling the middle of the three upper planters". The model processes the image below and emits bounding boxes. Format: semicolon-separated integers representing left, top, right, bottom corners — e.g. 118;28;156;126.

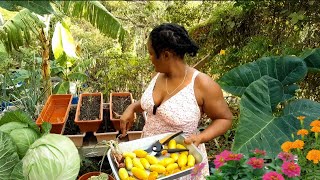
80;96;101;120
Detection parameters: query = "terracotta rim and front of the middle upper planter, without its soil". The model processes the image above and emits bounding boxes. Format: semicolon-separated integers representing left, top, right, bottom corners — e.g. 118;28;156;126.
74;93;103;132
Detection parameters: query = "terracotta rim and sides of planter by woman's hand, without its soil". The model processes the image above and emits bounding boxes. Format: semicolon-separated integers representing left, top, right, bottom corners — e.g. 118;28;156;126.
109;92;136;130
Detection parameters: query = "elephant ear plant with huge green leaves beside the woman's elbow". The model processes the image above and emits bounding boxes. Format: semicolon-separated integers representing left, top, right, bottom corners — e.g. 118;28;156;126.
219;51;320;157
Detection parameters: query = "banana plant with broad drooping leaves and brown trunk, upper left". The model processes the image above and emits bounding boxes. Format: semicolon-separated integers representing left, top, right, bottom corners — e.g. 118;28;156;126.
0;1;126;100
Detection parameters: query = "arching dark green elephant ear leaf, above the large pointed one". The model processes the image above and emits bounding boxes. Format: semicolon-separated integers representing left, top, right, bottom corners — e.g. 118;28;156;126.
218;56;307;96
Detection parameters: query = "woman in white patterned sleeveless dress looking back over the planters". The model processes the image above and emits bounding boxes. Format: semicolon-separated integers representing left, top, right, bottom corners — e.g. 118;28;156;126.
120;23;232;179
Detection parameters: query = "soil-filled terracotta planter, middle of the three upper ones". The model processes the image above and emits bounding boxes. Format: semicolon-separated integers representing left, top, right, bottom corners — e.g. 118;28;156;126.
74;92;103;132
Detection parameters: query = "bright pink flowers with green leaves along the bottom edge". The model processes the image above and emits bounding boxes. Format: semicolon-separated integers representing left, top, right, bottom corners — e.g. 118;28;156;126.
202;149;301;180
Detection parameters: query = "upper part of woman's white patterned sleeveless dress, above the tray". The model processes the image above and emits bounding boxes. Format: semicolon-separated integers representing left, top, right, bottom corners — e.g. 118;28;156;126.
141;71;201;137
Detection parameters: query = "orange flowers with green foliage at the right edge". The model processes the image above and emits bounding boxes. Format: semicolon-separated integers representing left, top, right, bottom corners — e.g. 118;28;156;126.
281;116;320;179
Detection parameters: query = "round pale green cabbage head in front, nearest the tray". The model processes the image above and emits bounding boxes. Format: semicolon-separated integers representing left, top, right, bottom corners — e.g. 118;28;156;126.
22;134;80;180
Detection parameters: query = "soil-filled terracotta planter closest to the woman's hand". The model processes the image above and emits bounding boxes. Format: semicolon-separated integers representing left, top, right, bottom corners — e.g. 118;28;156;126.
110;92;136;130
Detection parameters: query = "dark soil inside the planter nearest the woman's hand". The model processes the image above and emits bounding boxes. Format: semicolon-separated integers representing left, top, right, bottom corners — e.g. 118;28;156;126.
112;96;131;119
